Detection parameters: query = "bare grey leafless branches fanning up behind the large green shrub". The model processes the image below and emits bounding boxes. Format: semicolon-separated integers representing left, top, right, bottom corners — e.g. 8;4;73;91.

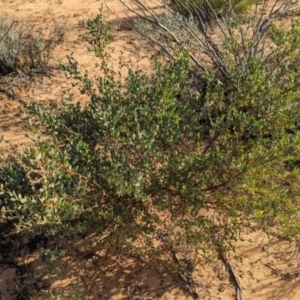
120;0;291;85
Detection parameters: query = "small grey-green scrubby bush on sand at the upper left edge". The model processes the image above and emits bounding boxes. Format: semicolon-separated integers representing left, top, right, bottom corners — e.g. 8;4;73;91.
0;15;65;100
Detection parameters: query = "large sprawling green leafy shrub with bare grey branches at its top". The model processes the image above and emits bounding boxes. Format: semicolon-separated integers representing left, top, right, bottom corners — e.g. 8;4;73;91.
0;0;300;299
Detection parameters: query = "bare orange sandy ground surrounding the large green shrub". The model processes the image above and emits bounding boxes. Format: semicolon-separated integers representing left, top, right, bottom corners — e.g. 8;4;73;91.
0;0;300;300
